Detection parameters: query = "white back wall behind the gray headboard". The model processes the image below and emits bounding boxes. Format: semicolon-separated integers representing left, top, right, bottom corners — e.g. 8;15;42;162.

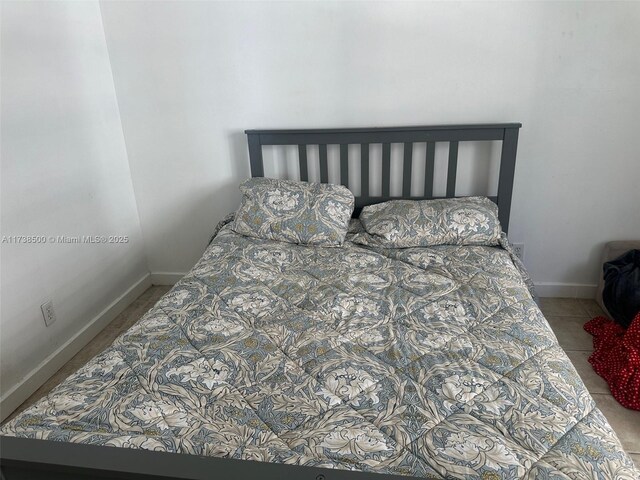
101;2;640;290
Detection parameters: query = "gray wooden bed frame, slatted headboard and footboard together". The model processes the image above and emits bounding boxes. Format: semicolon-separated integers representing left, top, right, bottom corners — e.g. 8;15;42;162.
0;123;521;480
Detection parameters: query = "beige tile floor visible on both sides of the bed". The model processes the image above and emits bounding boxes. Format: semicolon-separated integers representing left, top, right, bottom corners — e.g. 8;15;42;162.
3;286;640;466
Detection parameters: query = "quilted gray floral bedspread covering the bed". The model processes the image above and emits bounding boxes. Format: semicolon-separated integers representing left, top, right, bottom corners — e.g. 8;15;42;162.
1;226;640;480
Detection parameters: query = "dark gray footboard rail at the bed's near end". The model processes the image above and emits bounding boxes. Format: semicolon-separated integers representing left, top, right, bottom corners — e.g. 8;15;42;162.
0;436;417;480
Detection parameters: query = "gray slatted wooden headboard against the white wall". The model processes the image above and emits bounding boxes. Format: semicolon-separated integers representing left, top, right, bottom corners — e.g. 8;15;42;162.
245;123;522;232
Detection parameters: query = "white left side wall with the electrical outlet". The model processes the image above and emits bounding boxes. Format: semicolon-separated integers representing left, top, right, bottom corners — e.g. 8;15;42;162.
0;2;148;417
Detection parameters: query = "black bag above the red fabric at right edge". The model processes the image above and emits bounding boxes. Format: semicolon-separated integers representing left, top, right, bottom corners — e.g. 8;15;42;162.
602;250;640;328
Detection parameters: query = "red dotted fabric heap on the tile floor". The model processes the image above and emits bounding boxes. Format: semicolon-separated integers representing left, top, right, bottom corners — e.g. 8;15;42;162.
584;312;640;410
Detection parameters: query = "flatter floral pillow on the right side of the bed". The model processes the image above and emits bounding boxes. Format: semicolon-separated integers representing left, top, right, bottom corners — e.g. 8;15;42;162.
353;197;502;248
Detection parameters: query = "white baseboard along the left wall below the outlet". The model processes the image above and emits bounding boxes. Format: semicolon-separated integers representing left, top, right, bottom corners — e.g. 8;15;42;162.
0;273;152;421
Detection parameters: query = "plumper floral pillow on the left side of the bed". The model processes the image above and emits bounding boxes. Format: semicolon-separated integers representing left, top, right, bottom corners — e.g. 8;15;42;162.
232;177;354;246
